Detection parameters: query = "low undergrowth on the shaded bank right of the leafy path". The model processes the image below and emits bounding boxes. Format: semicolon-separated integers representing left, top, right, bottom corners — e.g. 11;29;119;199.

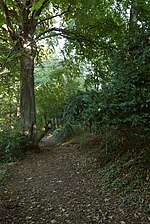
94;130;150;206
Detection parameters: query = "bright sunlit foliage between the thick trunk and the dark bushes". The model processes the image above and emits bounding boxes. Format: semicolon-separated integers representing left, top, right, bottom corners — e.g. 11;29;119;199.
35;57;81;131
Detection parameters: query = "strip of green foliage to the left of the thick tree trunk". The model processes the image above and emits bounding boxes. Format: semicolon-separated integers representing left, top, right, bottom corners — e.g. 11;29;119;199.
0;42;21;162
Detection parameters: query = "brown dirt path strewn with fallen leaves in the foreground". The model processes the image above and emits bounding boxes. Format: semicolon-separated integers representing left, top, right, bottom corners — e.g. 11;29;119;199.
0;139;150;224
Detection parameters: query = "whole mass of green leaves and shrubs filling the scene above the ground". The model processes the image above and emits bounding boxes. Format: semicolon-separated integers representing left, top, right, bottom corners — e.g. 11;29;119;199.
0;0;150;152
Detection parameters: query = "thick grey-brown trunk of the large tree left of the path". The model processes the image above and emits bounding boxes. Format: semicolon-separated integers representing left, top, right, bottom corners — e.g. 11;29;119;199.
20;42;36;146
